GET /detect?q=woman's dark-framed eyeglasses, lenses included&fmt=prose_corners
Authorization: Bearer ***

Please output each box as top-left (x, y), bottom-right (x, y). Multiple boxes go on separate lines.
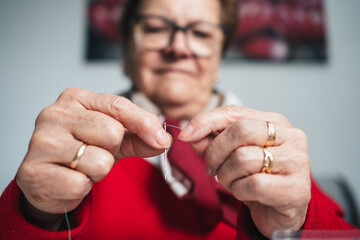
top-left (132, 15), bottom-right (225, 57)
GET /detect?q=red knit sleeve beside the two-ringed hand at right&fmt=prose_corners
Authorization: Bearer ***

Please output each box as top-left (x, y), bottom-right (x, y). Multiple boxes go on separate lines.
top-left (302, 180), bottom-right (355, 230)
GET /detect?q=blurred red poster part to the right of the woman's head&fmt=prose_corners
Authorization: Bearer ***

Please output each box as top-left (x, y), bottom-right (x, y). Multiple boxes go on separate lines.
top-left (229, 0), bottom-right (327, 62)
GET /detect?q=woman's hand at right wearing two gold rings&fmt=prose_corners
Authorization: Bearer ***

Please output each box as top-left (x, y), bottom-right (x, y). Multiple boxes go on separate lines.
top-left (179, 106), bottom-right (311, 237)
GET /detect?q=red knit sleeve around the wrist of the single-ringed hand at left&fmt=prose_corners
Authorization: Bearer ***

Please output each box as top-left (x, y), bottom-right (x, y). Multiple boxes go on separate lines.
top-left (0, 180), bottom-right (91, 240)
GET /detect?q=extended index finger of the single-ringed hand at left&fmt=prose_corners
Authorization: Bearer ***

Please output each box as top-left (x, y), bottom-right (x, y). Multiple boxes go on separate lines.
top-left (62, 88), bottom-right (170, 149)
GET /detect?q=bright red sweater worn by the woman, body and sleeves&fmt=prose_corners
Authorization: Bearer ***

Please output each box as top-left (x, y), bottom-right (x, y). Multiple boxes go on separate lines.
top-left (0, 157), bottom-right (353, 240)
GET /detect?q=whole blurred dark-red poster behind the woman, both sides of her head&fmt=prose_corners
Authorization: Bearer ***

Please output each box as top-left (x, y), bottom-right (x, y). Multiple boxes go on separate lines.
top-left (86, 0), bottom-right (327, 62)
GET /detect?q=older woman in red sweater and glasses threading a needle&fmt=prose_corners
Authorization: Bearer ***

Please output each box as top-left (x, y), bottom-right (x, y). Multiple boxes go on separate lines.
top-left (0, 0), bottom-right (351, 239)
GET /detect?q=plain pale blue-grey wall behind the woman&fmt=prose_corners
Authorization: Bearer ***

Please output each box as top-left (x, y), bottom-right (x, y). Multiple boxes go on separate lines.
top-left (0, 0), bottom-right (360, 218)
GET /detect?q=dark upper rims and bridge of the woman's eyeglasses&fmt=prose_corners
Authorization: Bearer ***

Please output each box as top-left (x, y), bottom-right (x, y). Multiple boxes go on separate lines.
top-left (130, 14), bottom-right (227, 56)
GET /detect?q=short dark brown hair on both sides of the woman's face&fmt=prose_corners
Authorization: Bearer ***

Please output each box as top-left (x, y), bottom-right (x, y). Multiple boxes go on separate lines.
top-left (118, 0), bottom-right (239, 57)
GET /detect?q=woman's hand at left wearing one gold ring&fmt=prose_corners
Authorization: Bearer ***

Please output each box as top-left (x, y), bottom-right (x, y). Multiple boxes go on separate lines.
top-left (16, 88), bottom-right (170, 216)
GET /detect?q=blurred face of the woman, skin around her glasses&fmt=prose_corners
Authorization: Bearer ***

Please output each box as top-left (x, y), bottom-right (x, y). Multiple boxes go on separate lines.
top-left (128, 0), bottom-right (222, 119)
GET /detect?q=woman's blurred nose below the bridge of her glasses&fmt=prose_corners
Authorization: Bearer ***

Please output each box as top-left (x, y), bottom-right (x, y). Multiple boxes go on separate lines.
top-left (166, 31), bottom-right (192, 57)
